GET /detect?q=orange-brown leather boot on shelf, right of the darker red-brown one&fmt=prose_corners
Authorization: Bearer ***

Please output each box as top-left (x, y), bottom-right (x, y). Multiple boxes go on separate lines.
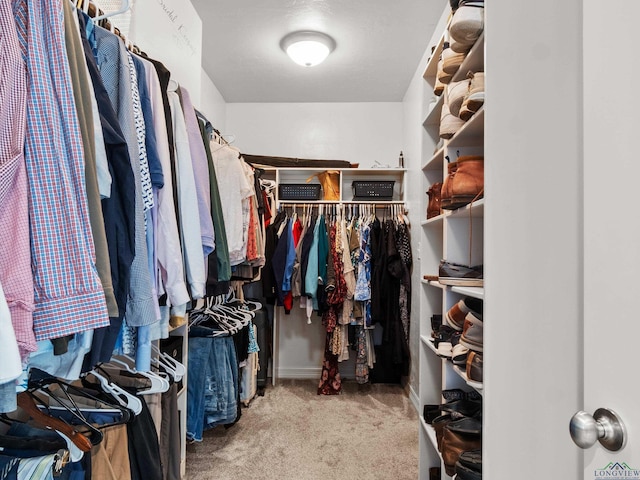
top-left (442, 155), bottom-right (484, 210)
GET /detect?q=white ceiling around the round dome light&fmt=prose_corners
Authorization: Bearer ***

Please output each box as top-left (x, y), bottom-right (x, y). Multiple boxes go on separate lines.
top-left (192, 0), bottom-right (443, 102)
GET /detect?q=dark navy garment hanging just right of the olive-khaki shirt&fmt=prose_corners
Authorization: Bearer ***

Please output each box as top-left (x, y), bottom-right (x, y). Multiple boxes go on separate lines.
top-left (78, 10), bottom-right (135, 371)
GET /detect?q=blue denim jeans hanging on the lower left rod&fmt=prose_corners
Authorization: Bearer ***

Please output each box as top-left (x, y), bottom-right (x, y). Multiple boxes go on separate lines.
top-left (187, 334), bottom-right (238, 442)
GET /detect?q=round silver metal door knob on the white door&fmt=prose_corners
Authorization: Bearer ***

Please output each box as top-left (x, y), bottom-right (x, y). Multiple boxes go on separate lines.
top-left (569, 408), bottom-right (627, 452)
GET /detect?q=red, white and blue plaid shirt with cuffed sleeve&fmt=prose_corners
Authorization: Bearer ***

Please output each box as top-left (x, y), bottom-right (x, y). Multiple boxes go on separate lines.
top-left (13, 0), bottom-right (109, 340)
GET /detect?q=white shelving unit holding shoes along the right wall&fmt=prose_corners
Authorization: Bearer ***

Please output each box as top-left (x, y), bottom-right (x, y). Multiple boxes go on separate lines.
top-left (418, 2), bottom-right (486, 480)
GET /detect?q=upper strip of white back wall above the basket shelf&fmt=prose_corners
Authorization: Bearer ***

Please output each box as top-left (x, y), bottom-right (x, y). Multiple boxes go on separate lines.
top-left (226, 102), bottom-right (402, 167)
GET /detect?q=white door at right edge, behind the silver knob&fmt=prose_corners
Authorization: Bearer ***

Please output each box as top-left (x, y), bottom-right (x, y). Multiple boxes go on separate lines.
top-left (582, 0), bottom-right (640, 480)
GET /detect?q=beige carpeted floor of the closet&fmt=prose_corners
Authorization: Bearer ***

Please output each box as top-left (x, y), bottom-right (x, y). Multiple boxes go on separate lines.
top-left (187, 380), bottom-right (418, 480)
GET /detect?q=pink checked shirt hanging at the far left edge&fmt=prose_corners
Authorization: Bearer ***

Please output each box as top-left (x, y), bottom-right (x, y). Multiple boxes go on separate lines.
top-left (0, 2), bottom-right (36, 356)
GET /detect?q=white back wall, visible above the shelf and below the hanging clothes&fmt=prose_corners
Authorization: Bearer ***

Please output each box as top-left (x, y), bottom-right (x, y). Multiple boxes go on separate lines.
top-left (224, 102), bottom-right (403, 379)
